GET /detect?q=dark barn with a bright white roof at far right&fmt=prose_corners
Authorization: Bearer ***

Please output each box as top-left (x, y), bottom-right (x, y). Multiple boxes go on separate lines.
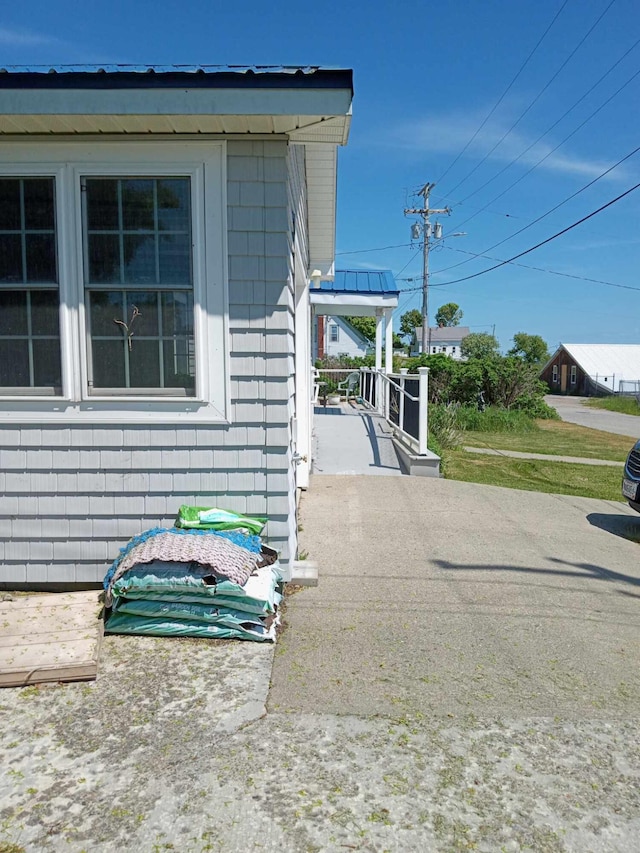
top-left (540, 344), bottom-right (640, 397)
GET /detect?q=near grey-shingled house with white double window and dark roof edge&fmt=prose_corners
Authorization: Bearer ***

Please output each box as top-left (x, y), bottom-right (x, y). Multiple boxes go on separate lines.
top-left (0, 66), bottom-right (353, 587)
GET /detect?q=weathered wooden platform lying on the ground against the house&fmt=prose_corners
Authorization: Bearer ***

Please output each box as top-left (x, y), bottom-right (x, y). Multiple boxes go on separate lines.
top-left (0, 590), bottom-right (102, 687)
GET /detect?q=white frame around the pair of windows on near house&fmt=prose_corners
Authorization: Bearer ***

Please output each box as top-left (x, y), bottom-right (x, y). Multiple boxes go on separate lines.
top-left (0, 139), bottom-right (230, 423)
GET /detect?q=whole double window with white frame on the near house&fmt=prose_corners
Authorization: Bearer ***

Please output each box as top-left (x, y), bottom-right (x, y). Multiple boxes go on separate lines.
top-left (0, 144), bottom-right (229, 423)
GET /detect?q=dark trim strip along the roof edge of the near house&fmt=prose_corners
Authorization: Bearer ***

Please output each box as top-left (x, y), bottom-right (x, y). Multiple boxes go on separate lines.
top-left (0, 65), bottom-right (353, 94)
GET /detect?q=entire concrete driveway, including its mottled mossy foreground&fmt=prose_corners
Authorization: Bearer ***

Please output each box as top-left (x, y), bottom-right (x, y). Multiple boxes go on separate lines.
top-left (0, 476), bottom-right (640, 853)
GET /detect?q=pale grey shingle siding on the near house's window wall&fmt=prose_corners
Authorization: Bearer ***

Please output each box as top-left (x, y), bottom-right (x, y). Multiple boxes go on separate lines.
top-left (0, 136), bottom-right (295, 586)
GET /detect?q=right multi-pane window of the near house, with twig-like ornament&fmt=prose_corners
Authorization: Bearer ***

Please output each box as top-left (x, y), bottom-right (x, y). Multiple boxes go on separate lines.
top-left (82, 177), bottom-right (195, 395)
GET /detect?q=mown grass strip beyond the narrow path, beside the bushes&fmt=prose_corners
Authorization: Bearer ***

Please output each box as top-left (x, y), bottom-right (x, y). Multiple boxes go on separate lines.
top-left (462, 421), bottom-right (632, 464)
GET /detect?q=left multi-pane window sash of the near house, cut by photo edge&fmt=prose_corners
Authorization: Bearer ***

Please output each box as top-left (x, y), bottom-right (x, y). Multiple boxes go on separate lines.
top-left (0, 177), bottom-right (62, 394)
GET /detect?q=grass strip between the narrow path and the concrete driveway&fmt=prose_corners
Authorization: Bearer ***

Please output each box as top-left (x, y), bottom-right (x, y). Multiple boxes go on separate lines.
top-left (447, 448), bottom-right (624, 503)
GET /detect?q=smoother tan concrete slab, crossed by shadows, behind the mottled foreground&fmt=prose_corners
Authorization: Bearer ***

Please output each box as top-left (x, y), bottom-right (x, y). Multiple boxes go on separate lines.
top-left (269, 477), bottom-right (640, 719)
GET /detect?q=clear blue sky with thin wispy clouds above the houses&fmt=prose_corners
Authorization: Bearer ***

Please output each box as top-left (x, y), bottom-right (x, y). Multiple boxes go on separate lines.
top-left (0, 0), bottom-right (640, 349)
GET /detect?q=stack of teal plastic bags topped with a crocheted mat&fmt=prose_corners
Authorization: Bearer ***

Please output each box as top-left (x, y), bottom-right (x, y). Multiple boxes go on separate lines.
top-left (104, 507), bottom-right (282, 641)
